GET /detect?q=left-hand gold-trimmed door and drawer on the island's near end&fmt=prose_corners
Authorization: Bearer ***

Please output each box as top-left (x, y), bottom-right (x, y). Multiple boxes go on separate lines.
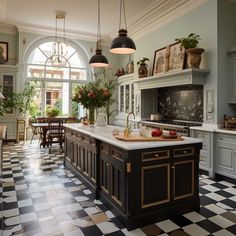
top-left (134, 149), bottom-right (170, 211)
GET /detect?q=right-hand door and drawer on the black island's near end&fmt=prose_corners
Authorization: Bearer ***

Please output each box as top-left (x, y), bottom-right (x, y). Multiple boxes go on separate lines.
top-left (171, 146), bottom-right (198, 200)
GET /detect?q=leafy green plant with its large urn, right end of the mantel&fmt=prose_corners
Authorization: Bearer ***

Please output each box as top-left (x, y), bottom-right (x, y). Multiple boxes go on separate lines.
top-left (175, 33), bottom-right (205, 68)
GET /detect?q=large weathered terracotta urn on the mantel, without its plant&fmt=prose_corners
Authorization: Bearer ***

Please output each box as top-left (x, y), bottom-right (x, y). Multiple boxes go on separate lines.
top-left (186, 48), bottom-right (205, 68)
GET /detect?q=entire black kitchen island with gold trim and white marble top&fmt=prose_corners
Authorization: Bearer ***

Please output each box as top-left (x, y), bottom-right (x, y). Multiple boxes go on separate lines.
top-left (64, 124), bottom-right (202, 230)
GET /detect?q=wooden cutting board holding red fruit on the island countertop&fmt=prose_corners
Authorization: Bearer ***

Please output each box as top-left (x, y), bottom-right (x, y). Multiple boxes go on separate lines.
top-left (114, 134), bottom-right (184, 142)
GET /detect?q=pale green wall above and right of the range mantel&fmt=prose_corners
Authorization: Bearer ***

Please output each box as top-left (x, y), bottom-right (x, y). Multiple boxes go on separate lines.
top-left (122, 0), bottom-right (217, 123)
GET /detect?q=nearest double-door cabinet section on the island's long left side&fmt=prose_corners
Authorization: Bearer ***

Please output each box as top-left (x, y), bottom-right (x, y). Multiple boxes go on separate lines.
top-left (100, 143), bottom-right (125, 211)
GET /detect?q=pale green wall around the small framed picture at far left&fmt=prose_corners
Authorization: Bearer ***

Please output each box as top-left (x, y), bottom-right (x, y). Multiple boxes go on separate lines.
top-left (0, 32), bottom-right (17, 65)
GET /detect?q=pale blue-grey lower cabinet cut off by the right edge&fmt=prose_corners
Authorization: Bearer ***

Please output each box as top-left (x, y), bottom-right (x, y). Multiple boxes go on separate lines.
top-left (215, 133), bottom-right (236, 179)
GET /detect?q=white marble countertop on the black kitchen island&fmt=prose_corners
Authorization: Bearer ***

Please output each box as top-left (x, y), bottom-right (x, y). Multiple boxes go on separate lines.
top-left (64, 123), bottom-right (202, 150)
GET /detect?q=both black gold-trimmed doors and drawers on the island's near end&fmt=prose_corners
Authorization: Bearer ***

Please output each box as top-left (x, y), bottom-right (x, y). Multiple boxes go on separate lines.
top-left (139, 146), bottom-right (198, 209)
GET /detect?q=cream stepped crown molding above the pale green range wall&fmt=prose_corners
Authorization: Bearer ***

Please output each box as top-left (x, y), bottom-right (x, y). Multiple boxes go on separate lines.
top-left (128, 0), bottom-right (209, 40)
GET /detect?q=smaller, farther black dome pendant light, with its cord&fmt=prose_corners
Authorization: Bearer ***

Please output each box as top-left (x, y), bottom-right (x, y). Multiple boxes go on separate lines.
top-left (89, 0), bottom-right (108, 67)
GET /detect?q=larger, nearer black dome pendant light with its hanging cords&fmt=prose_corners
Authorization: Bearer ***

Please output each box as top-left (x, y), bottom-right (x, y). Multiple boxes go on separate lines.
top-left (110, 0), bottom-right (136, 54)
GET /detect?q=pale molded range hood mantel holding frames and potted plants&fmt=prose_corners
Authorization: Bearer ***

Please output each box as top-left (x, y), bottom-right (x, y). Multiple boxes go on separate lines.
top-left (134, 68), bottom-right (210, 90)
